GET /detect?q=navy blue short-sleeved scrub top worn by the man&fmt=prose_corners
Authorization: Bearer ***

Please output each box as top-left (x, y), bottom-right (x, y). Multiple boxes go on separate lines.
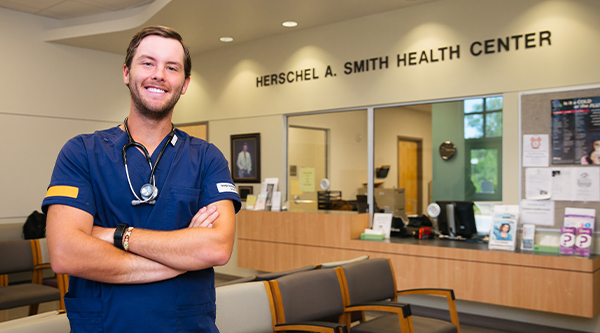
top-left (42, 127), bottom-right (241, 332)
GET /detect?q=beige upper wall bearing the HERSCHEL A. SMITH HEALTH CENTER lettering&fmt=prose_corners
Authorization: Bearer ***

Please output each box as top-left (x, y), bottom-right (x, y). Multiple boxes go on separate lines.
top-left (177, 0), bottom-right (600, 121)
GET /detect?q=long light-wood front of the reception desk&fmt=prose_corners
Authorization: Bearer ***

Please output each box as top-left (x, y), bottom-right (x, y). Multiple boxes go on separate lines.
top-left (237, 210), bottom-right (600, 318)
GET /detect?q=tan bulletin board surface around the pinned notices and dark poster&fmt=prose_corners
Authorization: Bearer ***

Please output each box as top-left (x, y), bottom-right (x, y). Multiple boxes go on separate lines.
top-left (520, 88), bottom-right (600, 232)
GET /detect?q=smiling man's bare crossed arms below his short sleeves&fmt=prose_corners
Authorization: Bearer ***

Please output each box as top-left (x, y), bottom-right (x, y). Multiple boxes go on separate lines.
top-left (46, 200), bottom-right (235, 284)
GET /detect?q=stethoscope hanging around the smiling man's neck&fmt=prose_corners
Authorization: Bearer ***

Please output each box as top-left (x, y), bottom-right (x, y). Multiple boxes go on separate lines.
top-left (121, 118), bottom-right (175, 206)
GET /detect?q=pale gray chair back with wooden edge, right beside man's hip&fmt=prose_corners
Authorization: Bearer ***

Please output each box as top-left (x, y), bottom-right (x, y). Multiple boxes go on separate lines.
top-left (216, 281), bottom-right (275, 333)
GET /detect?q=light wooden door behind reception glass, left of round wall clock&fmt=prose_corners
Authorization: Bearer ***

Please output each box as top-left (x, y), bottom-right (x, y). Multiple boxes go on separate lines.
top-left (398, 137), bottom-right (422, 215)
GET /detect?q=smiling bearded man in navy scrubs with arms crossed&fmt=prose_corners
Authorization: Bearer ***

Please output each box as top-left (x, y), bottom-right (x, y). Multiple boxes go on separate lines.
top-left (42, 26), bottom-right (241, 333)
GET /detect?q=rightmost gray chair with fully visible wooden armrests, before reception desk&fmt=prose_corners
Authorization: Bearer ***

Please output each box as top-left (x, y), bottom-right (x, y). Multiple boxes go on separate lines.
top-left (337, 258), bottom-right (460, 333)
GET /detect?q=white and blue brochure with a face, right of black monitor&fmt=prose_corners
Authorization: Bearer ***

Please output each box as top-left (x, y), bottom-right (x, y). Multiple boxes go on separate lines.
top-left (488, 205), bottom-right (519, 251)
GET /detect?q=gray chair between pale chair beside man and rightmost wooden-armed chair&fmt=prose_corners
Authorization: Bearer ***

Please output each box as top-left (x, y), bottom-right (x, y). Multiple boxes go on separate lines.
top-left (269, 268), bottom-right (348, 333)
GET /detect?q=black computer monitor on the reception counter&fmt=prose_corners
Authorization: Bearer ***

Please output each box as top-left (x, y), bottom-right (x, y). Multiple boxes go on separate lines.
top-left (437, 200), bottom-right (477, 238)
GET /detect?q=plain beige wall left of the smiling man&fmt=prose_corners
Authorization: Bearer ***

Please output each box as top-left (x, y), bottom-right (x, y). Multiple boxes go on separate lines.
top-left (0, 9), bottom-right (129, 223)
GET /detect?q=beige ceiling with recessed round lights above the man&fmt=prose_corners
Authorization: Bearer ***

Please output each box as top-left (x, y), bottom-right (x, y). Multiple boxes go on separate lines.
top-left (0, 0), bottom-right (439, 54)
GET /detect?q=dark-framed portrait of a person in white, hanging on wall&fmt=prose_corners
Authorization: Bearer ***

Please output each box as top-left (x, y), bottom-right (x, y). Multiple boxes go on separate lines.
top-left (231, 133), bottom-right (260, 183)
